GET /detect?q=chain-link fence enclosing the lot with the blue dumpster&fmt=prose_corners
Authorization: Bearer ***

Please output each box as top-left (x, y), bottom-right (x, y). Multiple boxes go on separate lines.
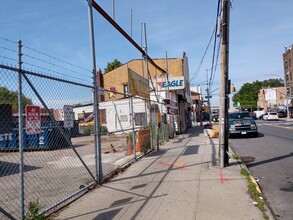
top-left (0, 40), bottom-right (172, 219)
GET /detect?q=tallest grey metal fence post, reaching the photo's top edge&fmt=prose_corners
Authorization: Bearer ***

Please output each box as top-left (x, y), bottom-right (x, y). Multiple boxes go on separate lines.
top-left (88, 0), bottom-right (103, 184)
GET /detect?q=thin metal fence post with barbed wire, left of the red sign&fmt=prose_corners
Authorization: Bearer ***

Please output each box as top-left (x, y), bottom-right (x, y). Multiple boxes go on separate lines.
top-left (17, 40), bottom-right (25, 219)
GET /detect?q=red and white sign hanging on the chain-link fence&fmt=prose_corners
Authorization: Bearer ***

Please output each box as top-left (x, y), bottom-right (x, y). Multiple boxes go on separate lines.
top-left (25, 105), bottom-right (41, 134)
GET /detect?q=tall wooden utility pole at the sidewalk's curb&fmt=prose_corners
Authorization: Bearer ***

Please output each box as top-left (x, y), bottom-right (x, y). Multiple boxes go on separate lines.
top-left (219, 0), bottom-right (230, 168)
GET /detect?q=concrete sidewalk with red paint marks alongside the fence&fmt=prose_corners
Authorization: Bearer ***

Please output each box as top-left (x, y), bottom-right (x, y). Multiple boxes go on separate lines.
top-left (54, 127), bottom-right (270, 220)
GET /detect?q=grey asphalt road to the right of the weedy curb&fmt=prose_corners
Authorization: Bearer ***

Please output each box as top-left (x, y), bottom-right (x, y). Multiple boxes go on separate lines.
top-left (229, 121), bottom-right (293, 220)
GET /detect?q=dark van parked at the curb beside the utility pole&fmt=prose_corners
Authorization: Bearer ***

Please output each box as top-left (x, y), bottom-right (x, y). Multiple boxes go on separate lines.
top-left (229, 112), bottom-right (258, 137)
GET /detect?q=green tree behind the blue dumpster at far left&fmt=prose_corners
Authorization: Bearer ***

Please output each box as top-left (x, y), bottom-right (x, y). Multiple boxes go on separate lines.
top-left (0, 87), bottom-right (33, 109)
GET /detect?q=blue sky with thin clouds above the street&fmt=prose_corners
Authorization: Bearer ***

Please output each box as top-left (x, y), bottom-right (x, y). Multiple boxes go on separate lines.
top-left (0, 0), bottom-right (293, 105)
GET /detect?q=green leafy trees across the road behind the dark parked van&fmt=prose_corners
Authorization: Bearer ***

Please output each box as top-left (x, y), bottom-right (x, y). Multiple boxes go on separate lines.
top-left (233, 79), bottom-right (284, 110)
